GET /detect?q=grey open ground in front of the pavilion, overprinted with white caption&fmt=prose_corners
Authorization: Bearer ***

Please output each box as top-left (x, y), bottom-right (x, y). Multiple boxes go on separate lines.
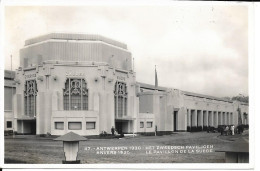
top-left (5, 132), bottom-right (248, 164)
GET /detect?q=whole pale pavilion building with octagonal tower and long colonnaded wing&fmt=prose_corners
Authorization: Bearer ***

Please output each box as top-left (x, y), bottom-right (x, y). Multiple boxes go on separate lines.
top-left (4, 33), bottom-right (249, 135)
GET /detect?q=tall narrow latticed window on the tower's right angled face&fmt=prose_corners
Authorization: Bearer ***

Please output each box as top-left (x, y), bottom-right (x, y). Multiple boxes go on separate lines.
top-left (114, 81), bottom-right (127, 118)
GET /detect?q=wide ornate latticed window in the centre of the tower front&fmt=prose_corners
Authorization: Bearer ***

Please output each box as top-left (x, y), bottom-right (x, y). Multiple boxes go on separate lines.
top-left (63, 78), bottom-right (88, 110)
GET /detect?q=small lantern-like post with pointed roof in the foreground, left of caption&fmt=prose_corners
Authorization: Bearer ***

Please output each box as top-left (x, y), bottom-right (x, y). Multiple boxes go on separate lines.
top-left (54, 132), bottom-right (87, 164)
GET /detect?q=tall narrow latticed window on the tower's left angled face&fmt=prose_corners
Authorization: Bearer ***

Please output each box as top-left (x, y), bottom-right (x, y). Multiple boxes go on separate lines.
top-left (24, 80), bottom-right (37, 117)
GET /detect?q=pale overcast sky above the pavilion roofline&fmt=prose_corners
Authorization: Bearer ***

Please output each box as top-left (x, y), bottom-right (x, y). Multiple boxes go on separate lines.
top-left (4, 5), bottom-right (248, 97)
